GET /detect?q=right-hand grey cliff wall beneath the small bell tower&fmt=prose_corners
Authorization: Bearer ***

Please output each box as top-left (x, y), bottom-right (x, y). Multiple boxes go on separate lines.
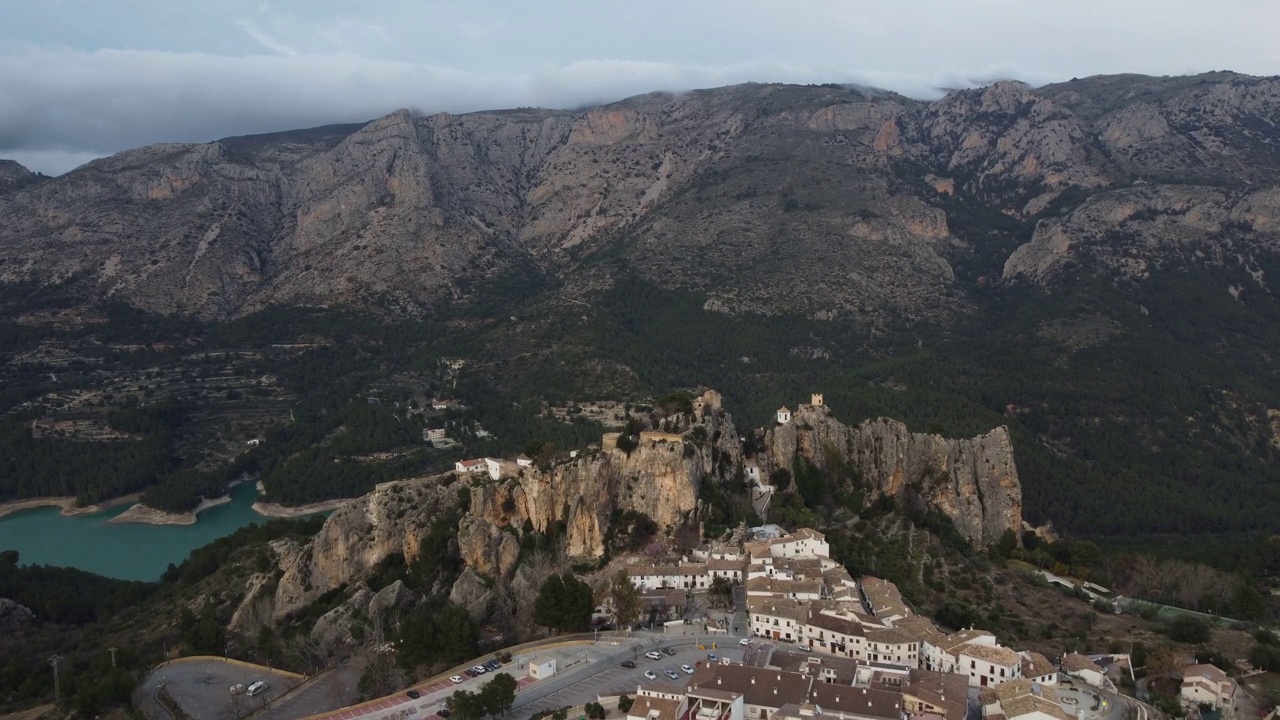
top-left (758, 405), bottom-right (1023, 547)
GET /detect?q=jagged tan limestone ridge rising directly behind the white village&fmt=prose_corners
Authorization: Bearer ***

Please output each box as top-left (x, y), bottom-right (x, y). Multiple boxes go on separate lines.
top-left (264, 392), bottom-right (1021, 634)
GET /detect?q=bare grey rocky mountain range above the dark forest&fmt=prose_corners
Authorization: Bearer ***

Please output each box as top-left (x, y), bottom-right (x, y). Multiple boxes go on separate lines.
top-left (0, 73), bottom-right (1280, 325)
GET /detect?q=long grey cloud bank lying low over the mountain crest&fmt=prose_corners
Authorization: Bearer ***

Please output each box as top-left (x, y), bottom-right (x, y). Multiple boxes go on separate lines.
top-left (0, 45), bottom-right (1059, 173)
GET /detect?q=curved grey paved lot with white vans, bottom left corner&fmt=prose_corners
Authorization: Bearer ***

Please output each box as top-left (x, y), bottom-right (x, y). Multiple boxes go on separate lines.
top-left (138, 660), bottom-right (298, 720)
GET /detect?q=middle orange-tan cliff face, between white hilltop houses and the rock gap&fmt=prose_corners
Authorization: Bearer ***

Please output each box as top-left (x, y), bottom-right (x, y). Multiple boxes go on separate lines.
top-left (458, 411), bottom-right (741, 578)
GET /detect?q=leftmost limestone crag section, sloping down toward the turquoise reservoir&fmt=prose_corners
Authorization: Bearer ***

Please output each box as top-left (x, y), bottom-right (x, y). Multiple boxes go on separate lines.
top-left (273, 477), bottom-right (457, 619)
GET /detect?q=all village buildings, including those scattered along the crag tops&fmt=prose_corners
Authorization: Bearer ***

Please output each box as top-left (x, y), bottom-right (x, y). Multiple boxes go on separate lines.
top-left (442, 391), bottom-right (1245, 720)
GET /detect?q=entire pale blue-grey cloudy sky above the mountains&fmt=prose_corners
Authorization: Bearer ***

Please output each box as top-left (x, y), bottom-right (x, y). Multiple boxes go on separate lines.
top-left (0, 0), bottom-right (1280, 174)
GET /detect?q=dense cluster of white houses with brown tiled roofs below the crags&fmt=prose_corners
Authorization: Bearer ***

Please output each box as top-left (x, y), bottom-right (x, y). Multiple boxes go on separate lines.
top-left (604, 525), bottom-right (1128, 720)
